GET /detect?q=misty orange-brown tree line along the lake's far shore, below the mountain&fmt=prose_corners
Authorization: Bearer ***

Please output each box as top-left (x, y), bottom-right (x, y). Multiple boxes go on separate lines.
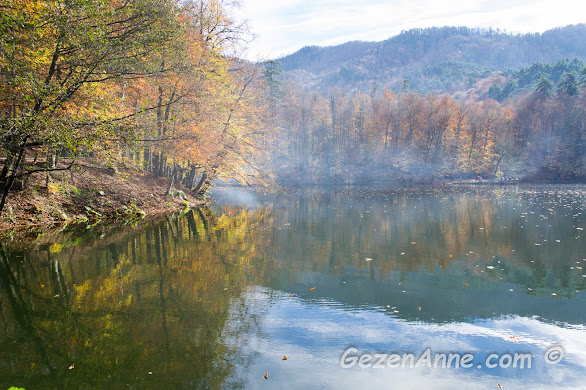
top-left (274, 64), bottom-right (586, 183)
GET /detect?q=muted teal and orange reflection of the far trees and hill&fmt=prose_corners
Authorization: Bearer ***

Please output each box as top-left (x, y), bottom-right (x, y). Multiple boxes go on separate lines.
top-left (238, 188), bottom-right (586, 324)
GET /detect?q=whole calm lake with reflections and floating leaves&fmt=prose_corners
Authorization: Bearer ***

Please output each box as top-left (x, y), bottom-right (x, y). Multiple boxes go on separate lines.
top-left (0, 185), bottom-right (586, 389)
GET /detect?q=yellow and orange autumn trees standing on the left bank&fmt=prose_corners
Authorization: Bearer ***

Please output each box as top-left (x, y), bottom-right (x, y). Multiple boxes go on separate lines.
top-left (0, 0), bottom-right (265, 212)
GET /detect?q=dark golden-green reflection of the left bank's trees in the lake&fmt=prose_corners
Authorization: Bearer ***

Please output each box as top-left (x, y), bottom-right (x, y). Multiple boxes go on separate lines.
top-left (0, 209), bottom-right (271, 388)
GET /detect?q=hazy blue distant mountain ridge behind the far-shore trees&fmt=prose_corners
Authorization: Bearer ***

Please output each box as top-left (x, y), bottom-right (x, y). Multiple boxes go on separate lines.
top-left (278, 24), bottom-right (586, 93)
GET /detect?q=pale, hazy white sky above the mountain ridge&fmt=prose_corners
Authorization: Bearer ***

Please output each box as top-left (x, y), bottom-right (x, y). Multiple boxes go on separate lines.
top-left (237, 0), bottom-right (586, 60)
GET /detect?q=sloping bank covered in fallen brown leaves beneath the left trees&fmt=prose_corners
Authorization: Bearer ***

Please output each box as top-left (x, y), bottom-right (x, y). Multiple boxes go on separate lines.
top-left (0, 162), bottom-right (205, 230)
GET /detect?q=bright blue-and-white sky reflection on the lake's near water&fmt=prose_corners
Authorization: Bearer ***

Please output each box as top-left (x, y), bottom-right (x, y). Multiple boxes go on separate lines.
top-left (228, 287), bottom-right (586, 389)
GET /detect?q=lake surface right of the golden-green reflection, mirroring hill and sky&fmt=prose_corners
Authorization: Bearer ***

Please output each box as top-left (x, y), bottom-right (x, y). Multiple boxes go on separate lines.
top-left (215, 186), bottom-right (586, 389)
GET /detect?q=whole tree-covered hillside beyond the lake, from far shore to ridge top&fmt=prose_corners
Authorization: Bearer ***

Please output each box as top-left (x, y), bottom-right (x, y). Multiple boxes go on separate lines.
top-left (266, 24), bottom-right (586, 183)
